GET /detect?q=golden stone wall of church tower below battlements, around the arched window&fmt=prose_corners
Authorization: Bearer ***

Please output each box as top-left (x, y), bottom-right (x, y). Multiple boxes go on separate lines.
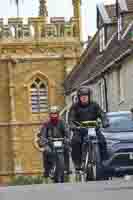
top-left (0, 18), bottom-right (81, 182)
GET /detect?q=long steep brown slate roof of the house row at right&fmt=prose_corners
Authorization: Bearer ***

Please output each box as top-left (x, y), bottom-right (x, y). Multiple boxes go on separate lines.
top-left (64, 0), bottom-right (133, 93)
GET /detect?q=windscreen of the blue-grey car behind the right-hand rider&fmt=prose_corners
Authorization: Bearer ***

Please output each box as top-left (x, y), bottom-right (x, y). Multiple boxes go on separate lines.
top-left (104, 115), bottom-right (133, 132)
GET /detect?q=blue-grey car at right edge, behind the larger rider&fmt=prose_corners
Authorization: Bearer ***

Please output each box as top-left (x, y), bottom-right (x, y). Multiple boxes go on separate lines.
top-left (97, 111), bottom-right (133, 177)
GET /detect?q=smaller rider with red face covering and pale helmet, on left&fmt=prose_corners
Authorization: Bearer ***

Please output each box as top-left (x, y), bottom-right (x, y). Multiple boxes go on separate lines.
top-left (38, 106), bottom-right (70, 181)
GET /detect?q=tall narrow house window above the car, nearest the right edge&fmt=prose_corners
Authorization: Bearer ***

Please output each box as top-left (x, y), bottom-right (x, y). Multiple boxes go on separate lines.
top-left (117, 68), bottom-right (124, 103)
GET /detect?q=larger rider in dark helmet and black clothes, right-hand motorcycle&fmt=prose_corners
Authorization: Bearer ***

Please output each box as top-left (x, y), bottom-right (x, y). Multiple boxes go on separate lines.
top-left (69, 86), bottom-right (108, 169)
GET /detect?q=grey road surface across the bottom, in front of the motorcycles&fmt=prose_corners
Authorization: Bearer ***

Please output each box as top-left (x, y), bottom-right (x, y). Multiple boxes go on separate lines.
top-left (0, 180), bottom-right (133, 200)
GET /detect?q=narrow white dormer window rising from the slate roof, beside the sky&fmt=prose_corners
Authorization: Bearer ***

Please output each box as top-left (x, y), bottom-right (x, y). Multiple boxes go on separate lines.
top-left (99, 27), bottom-right (106, 52)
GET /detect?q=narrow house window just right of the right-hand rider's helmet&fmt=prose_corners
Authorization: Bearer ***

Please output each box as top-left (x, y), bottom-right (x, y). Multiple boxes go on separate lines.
top-left (98, 81), bottom-right (106, 111)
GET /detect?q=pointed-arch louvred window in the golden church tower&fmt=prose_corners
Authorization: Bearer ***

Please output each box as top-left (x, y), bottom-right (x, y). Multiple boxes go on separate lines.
top-left (30, 78), bottom-right (48, 113)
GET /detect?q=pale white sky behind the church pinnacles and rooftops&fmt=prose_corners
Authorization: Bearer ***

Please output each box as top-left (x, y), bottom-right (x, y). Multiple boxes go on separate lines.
top-left (0, 0), bottom-right (115, 41)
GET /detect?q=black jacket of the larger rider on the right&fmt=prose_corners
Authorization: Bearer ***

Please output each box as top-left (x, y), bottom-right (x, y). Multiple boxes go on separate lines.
top-left (69, 102), bottom-right (108, 127)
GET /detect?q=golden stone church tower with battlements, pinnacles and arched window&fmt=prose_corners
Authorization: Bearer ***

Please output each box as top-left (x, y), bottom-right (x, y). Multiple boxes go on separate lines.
top-left (0, 0), bottom-right (81, 183)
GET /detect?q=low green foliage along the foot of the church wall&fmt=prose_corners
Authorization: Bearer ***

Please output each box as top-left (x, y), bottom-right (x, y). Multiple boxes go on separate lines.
top-left (9, 176), bottom-right (44, 185)
